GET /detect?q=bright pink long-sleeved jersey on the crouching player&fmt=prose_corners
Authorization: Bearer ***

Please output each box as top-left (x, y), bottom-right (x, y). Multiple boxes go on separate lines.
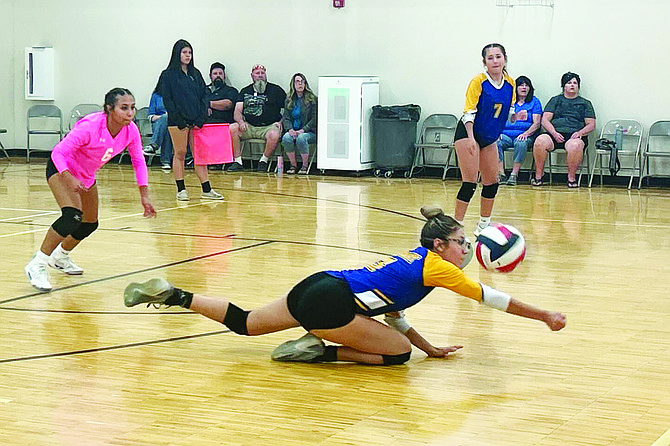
top-left (51, 112), bottom-right (148, 188)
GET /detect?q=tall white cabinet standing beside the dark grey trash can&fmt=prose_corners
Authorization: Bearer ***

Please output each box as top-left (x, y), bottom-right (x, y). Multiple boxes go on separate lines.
top-left (316, 76), bottom-right (379, 171)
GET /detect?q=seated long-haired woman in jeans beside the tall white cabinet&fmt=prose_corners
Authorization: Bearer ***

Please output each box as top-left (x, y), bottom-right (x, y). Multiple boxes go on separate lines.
top-left (281, 73), bottom-right (317, 175)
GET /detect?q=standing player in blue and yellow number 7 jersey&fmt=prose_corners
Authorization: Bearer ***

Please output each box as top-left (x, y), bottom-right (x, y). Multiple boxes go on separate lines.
top-left (454, 43), bottom-right (528, 236)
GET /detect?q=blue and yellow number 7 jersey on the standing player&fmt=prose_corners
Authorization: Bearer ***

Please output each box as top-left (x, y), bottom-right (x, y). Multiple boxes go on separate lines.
top-left (463, 73), bottom-right (516, 142)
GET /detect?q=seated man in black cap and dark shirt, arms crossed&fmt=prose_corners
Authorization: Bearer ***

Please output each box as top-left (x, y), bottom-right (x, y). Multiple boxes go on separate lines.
top-left (205, 62), bottom-right (242, 170)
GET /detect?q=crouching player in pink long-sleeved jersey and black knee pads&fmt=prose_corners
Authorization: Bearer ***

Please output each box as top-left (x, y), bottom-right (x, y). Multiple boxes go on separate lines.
top-left (25, 88), bottom-right (156, 291)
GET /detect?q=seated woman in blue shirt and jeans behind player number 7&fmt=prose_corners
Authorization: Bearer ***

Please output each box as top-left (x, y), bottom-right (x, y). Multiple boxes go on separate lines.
top-left (497, 76), bottom-right (542, 186)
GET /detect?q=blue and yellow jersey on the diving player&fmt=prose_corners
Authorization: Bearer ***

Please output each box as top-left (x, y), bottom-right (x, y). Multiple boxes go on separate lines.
top-left (326, 247), bottom-right (482, 316)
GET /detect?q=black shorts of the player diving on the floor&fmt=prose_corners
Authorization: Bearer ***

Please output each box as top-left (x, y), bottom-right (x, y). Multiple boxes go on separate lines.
top-left (287, 272), bottom-right (356, 330)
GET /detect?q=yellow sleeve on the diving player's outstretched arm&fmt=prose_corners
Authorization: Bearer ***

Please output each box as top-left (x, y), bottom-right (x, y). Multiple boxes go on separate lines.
top-left (423, 251), bottom-right (482, 302)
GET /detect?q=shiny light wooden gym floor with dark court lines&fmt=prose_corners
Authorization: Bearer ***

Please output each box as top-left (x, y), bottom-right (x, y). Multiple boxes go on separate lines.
top-left (0, 158), bottom-right (670, 446)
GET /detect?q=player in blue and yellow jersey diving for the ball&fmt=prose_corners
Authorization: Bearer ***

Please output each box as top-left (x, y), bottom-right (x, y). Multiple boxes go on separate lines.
top-left (124, 207), bottom-right (566, 365)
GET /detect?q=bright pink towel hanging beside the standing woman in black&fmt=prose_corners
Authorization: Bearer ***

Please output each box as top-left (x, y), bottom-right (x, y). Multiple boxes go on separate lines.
top-left (193, 124), bottom-right (233, 166)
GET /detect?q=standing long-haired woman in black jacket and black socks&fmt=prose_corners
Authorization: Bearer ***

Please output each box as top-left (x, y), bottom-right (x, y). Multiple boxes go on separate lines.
top-left (159, 39), bottom-right (223, 201)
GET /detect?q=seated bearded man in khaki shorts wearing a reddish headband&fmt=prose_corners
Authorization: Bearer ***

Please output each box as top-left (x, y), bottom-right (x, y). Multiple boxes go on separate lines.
top-left (235, 65), bottom-right (286, 172)
